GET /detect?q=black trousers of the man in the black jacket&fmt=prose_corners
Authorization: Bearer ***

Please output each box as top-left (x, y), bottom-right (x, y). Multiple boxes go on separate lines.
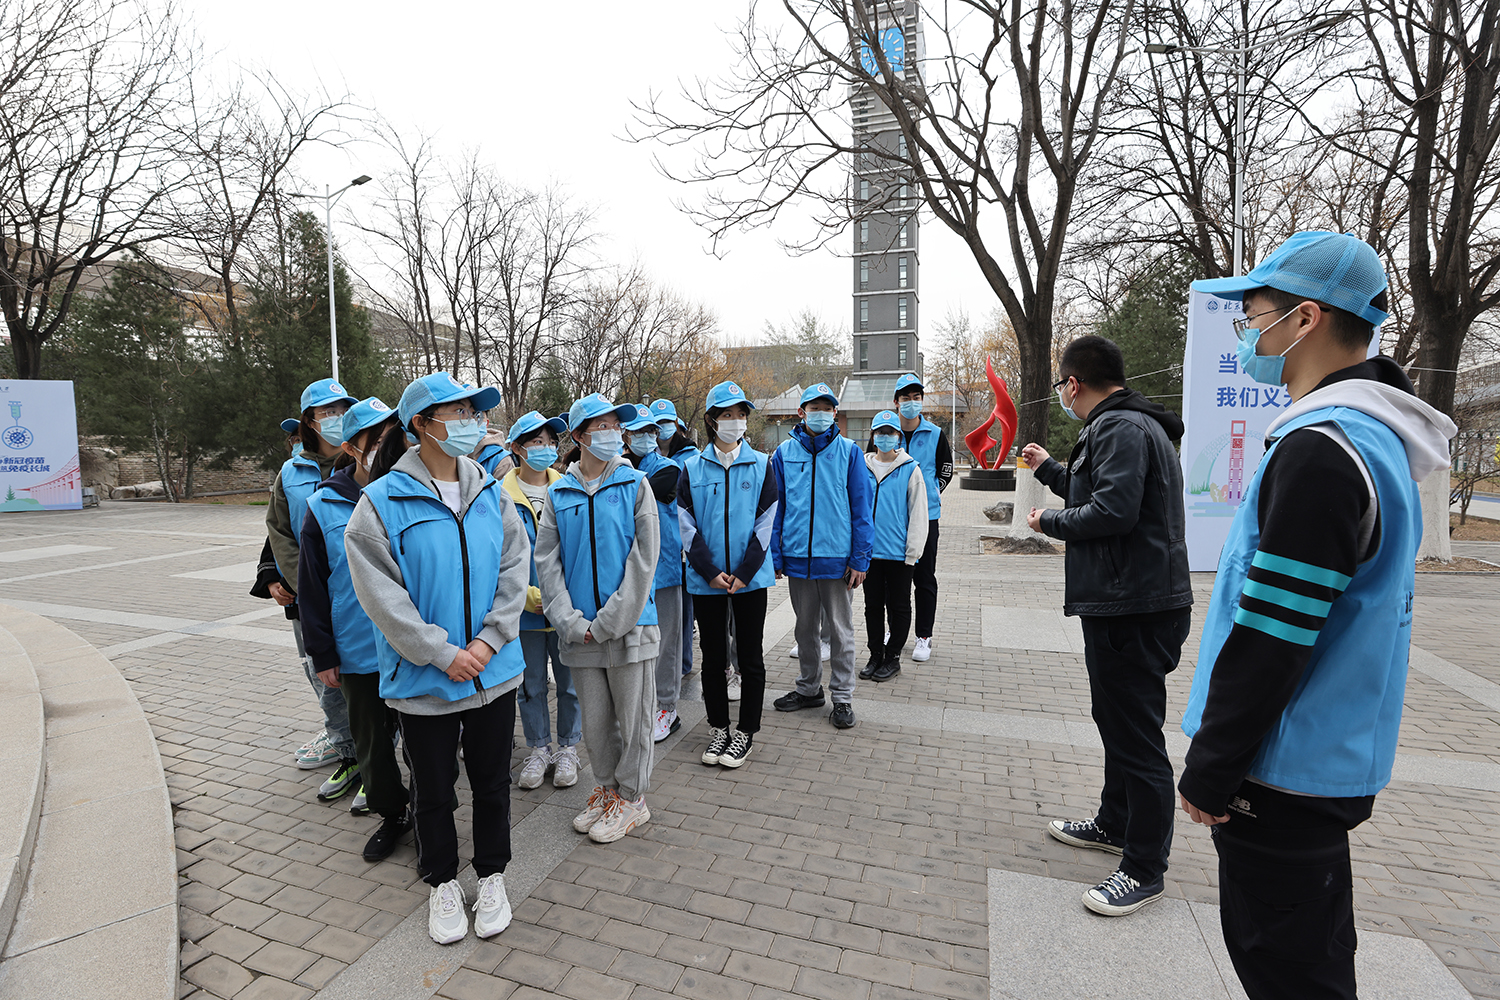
top-left (1082, 607), bottom-right (1191, 885)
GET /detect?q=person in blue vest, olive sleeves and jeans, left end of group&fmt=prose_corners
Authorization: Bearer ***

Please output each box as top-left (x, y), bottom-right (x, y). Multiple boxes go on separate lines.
top-left (266, 378), bottom-right (359, 799)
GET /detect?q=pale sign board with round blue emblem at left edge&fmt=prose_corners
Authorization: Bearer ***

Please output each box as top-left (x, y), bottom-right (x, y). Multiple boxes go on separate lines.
top-left (0, 379), bottom-right (84, 511)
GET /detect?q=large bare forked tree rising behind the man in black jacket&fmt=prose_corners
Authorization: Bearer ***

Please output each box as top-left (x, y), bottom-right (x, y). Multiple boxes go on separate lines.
top-left (635, 0), bottom-right (1137, 441)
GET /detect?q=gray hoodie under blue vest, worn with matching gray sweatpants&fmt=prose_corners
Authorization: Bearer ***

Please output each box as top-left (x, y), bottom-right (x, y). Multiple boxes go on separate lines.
top-left (536, 457), bottom-right (662, 667)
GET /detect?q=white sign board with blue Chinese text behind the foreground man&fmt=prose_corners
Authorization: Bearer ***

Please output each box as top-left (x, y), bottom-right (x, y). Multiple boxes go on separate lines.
top-left (1182, 291), bottom-right (1292, 571)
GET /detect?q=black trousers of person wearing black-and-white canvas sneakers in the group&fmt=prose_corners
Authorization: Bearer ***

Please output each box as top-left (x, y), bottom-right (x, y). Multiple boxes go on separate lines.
top-left (693, 588), bottom-right (767, 733)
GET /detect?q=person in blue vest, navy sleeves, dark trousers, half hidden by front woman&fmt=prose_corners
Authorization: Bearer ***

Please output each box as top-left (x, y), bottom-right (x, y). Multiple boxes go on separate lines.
top-left (297, 396), bottom-right (411, 862)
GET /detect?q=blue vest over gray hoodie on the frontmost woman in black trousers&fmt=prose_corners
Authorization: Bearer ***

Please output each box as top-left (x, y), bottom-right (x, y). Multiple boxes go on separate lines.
top-left (365, 459), bottom-right (525, 702)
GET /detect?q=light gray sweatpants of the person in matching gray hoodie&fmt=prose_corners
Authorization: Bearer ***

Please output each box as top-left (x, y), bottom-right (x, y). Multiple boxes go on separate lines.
top-left (573, 660), bottom-right (656, 802)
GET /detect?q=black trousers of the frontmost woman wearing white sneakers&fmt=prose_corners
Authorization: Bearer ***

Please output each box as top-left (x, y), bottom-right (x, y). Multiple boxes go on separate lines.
top-left (396, 691), bottom-right (516, 886)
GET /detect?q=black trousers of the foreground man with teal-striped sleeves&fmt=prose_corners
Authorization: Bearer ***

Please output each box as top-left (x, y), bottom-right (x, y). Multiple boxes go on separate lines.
top-left (1214, 781), bottom-right (1376, 1000)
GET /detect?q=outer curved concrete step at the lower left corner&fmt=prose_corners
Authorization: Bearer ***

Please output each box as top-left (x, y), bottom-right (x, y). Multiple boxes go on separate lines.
top-left (0, 604), bottom-right (177, 1000)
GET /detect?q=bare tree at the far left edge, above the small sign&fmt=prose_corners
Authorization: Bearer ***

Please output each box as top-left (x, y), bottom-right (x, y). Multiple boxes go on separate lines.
top-left (0, 0), bottom-right (195, 378)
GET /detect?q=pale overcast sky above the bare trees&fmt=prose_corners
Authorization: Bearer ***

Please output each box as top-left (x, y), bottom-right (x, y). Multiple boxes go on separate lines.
top-left (188, 0), bottom-right (995, 357)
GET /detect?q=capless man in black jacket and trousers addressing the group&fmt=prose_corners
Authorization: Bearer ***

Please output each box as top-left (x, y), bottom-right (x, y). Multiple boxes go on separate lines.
top-left (1022, 336), bottom-right (1193, 916)
